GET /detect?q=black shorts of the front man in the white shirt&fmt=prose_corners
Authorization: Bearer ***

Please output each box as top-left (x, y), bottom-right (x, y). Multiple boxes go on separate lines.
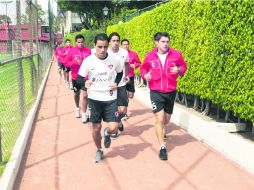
top-left (88, 98), bottom-right (119, 123)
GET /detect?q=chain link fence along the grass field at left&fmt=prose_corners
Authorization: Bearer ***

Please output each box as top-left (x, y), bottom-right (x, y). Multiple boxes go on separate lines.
top-left (0, 0), bottom-right (52, 174)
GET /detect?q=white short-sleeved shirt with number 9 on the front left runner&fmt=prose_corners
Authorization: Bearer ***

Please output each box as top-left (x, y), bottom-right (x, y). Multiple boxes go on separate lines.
top-left (78, 54), bottom-right (122, 101)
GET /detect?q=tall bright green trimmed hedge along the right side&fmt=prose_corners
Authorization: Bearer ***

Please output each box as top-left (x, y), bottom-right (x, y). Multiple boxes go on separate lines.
top-left (107, 0), bottom-right (254, 122)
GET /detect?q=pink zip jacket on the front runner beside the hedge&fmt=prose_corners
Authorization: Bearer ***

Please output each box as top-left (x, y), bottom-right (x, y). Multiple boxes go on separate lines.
top-left (140, 48), bottom-right (187, 93)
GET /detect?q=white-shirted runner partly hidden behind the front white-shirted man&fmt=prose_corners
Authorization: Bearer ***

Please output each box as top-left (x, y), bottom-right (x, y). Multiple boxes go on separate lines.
top-left (108, 32), bottom-right (129, 135)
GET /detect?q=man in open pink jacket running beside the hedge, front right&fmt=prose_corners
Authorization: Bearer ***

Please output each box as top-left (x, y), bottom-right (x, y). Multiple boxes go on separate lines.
top-left (140, 32), bottom-right (186, 160)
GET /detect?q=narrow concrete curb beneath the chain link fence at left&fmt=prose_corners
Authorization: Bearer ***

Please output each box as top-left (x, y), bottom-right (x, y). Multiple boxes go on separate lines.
top-left (0, 63), bottom-right (52, 190)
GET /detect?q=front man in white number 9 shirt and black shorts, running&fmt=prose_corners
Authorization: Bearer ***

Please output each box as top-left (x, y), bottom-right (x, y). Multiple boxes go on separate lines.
top-left (78, 33), bottom-right (123, 162)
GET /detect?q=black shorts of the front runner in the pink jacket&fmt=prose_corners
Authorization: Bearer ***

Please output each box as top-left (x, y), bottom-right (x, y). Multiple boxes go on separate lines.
top-left (150, 90), bottom-right (176, 114)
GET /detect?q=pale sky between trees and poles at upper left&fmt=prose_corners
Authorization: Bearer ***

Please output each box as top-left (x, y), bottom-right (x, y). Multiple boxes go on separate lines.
top-left (0, 0), bottom-right (57, 24)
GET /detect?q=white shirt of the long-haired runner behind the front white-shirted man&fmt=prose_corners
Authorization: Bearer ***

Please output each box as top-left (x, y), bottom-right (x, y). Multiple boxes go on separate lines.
top-left (108, 47), bottom-right (129, 86)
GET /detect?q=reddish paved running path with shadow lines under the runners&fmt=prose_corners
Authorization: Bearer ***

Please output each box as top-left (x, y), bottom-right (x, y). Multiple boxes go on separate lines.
top-left (14, 65), bottom-right (254, 190)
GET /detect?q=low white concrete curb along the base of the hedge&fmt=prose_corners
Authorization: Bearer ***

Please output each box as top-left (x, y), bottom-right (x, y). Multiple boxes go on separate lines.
top-left (135, 88), bottom-right (254, 174)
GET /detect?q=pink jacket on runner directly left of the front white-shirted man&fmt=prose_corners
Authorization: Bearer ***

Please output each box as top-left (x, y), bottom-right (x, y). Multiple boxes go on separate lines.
top-left (64, 46), bottom-right (91, 80)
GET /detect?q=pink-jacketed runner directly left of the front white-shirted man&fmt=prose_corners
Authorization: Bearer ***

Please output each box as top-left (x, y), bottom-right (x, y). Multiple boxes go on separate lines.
top-left (65, 34), bottom-right (91, 123)
